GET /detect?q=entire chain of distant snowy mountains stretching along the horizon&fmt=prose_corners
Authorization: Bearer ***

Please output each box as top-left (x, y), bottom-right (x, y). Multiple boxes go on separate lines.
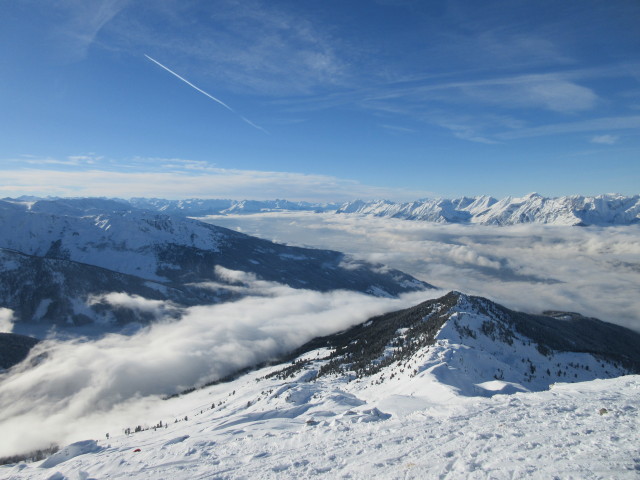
top-left (5, 193), bottom-right (640, 226)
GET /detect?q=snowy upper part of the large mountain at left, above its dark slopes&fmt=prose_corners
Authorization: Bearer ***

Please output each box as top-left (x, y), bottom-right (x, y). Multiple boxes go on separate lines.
top-left (0, 199), bottom-right (225, 280)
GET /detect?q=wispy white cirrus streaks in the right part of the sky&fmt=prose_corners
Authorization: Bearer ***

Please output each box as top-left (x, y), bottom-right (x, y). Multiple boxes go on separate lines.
top-left (318, 69), bottom-right (621, 144)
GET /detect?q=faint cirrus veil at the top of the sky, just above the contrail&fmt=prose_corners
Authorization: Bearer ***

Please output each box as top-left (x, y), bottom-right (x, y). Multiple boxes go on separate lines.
top-left (110, 0), bottom-right (349, 96)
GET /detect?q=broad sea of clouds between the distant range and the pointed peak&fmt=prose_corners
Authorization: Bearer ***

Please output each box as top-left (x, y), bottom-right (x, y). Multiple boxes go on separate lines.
top-left (200, 212), bottom-right (640, 330)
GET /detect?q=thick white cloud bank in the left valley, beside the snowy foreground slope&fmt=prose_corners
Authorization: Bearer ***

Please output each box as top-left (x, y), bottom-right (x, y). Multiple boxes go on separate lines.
top-left (0, 272), bottom-right (442, 456)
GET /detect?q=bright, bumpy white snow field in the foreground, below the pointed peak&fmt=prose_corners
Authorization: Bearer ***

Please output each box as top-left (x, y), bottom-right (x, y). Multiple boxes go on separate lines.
top-left (0, 370), bottom-right (640, 479)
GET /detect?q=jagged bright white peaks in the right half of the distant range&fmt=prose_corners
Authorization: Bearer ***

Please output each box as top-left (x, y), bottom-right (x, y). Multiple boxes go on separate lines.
top-left (337, 193), bottom-right (640, 226)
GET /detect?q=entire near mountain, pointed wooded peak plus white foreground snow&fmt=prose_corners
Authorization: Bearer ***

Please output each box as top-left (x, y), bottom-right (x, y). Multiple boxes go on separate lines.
top-left (0, 292), bottom-right (640, 479)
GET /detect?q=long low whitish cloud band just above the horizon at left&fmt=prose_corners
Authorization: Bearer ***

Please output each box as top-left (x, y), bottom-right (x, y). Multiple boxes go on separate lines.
top-left (0, 167), bottom-right (433, 202)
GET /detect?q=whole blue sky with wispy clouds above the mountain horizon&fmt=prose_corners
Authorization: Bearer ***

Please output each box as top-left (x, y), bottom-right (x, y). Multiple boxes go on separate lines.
top-left (0, 0), bottom-right (640, 200)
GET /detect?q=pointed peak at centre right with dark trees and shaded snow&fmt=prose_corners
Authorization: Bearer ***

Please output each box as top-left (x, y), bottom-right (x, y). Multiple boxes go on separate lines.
top-left (278, 292), bottom-right (640, 396)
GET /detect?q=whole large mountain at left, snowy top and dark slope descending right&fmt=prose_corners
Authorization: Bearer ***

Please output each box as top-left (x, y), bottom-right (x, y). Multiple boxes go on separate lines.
top-left (0, 199), bottom-right (428, 325)
